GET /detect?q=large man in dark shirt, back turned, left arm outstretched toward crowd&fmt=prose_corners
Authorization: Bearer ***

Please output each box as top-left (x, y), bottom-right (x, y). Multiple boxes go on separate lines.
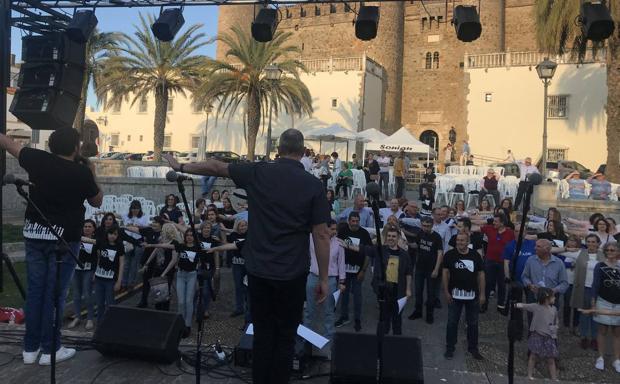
top-left (164, 129), bottom-right (330, 384)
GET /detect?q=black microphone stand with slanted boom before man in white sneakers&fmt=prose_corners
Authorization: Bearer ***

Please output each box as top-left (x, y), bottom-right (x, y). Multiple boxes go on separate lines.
top-left (15, 185), bottom-right (84, 384)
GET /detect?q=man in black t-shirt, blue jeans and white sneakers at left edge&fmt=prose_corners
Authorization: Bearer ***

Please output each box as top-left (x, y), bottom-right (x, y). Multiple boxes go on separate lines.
top-left (0, 128), bottom-right (103, 365)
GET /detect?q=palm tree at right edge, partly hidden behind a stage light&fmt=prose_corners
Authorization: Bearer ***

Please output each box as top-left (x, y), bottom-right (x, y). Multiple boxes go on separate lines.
top-left (534, 0), bottom-right (620, 182)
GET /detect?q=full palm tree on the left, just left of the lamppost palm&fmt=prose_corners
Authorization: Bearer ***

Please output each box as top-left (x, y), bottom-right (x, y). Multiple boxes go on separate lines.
top-left (96, 15), bottom-right (212, 161)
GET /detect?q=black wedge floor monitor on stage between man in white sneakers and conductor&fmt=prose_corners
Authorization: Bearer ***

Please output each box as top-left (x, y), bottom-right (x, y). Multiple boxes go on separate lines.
top-left (93, 305), bottom-right (185, 364)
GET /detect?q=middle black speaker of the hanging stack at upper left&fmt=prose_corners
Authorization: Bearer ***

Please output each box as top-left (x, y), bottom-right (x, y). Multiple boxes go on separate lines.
top-left (17, 63), bottom-right (85, 97)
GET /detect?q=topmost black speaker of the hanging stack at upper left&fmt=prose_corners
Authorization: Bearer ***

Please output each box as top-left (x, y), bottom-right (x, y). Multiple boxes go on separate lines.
top-left (22, 32), bottom-right (86, 67)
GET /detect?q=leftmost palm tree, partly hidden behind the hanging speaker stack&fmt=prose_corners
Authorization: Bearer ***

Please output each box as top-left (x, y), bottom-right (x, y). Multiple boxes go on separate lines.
top-left (73, 30), bottom-right (121, 133)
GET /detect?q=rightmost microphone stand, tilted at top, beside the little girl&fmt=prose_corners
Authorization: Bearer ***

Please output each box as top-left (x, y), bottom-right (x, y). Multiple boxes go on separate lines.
top-left (506, 181), bottom-right (534, 384)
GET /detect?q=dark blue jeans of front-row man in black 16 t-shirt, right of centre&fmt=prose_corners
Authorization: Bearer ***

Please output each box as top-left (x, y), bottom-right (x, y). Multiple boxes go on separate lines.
top-left (446, 297), bottom-right (480, 352)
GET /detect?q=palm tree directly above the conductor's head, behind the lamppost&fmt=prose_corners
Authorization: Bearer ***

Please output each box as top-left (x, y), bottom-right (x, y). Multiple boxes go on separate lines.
top-left (194, 26), bottom-right (312, 160)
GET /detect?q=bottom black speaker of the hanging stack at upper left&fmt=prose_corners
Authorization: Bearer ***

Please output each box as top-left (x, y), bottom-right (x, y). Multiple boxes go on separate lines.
top-left (9, 88), bottom-right (80, 130)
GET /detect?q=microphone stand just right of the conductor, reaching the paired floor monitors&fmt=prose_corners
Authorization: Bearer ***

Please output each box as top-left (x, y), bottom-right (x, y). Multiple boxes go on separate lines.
top-left (371, 190), bottom-right (389, 383)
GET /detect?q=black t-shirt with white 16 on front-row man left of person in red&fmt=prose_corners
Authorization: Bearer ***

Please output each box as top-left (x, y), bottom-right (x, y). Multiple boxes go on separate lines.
top-left (443, 249), bottom-right (483, 300)
